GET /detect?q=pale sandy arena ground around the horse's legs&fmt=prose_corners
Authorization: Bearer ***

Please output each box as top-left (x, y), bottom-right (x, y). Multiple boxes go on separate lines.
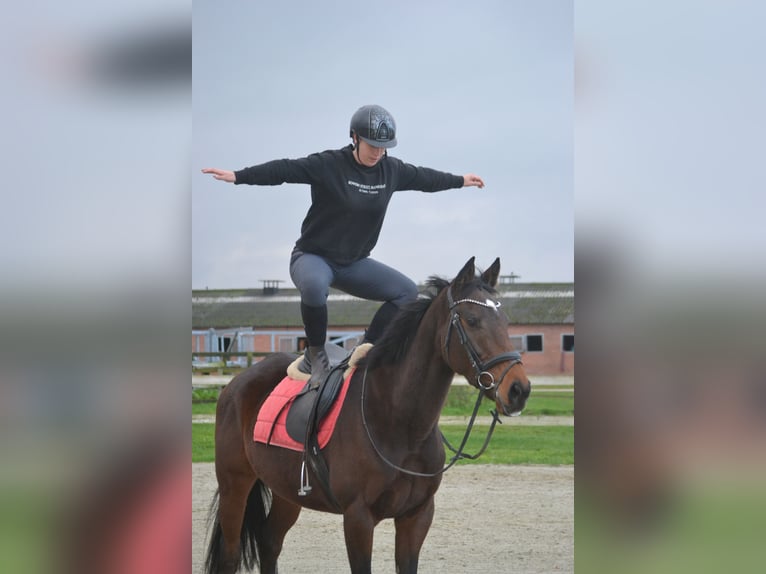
top-left (192, 463), bottom-right (574, 574)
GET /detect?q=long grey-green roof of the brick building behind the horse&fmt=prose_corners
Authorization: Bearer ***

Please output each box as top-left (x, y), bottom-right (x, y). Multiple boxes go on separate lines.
top-left (192, 283), bottom-right (574, 329)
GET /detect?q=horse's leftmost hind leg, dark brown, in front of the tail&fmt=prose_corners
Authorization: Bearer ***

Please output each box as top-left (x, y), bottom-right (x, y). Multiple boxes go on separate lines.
top-left (218, 474), bottom-right (255, 574)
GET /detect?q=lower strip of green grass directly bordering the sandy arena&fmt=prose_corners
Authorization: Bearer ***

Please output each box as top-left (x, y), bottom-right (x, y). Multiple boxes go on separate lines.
top-left (192, 423), bottom-right (574, 465)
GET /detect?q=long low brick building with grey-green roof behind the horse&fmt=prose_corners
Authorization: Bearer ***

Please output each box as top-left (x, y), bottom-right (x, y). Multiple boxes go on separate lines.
top-left (192, 283), bottom-right (574, 375)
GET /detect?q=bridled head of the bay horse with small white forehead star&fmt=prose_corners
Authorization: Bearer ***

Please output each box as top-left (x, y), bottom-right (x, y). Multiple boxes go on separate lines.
top-left (441, 257), bottom-right (531, 416)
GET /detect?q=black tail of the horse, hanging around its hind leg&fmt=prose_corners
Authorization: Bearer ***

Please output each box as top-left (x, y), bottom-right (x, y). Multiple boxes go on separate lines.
top-left (205, 480), bottom-right (271, 574)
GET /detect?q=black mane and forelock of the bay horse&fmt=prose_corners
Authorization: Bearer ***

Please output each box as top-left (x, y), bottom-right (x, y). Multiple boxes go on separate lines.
top-left (365, 276), bottom-right (495, 369)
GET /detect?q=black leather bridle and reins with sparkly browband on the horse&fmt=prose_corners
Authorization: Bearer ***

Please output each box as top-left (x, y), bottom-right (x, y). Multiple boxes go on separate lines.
top-left (361, 285), bottom-right (521, 478)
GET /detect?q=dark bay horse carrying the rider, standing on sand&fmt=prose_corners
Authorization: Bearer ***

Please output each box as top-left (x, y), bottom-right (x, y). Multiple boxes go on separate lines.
top-left (206, 258), bottom-right (530, 574)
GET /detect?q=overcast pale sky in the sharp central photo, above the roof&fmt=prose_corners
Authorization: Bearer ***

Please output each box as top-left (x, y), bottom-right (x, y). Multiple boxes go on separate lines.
top-left (191, 0), bottom-right (574, 289)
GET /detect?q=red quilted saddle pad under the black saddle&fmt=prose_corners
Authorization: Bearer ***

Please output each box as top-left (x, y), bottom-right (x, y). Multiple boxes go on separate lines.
top-left (253, 369), bottom-right (354, 451)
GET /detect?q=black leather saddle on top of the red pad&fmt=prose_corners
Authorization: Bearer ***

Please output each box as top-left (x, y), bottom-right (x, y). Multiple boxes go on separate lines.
top-left (285, 343), bottom-right (351, 445)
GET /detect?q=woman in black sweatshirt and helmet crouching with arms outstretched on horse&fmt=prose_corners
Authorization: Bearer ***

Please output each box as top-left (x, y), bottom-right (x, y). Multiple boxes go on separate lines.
top-left (202, 105), bottom-right (484, 390)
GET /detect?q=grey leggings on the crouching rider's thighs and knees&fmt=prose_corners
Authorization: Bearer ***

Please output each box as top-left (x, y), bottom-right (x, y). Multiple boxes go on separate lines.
top-left (290, 250), bottom-right (418, 307)
